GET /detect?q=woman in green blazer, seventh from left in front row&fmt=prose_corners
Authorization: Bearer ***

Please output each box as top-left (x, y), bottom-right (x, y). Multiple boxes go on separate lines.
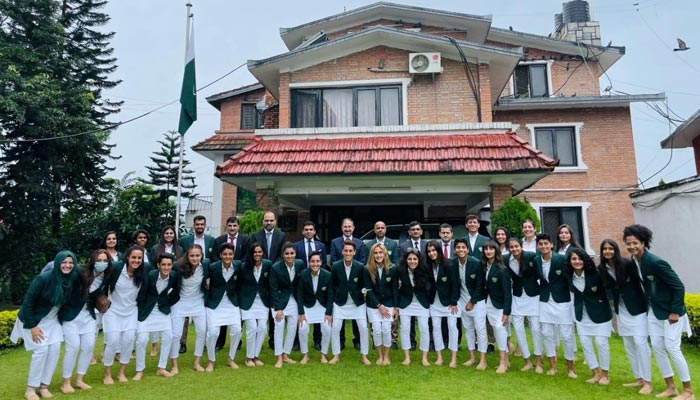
top-left (238, 243), bottom-right (272, 367)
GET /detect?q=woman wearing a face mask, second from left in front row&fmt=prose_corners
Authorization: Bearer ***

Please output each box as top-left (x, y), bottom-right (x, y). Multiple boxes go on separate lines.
top-left (60, 250), bottom-right (112, 393)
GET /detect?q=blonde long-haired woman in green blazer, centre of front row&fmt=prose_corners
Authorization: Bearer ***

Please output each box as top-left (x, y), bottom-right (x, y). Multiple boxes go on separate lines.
top-left (364, 244), bottom-right (399, 365)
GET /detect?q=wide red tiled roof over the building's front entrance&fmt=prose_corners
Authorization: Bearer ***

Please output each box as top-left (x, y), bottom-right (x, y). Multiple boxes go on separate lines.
top-left (216, 132), bottom-right (559, 176)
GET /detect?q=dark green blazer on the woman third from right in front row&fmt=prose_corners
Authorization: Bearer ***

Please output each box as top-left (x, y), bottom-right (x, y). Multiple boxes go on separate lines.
top-left (569, 269), bottom-right (612, 324)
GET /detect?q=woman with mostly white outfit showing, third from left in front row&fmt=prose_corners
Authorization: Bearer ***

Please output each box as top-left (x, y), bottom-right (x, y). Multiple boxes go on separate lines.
top-left (102, 246), bottom-right (146, 385)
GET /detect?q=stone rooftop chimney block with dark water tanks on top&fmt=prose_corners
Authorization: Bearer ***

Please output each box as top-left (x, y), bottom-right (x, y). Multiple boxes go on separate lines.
top-left (552, 0), bottom-right (600, 46)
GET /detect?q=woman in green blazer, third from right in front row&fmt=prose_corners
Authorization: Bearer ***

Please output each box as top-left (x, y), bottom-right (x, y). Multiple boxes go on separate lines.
top-left (566, 248), bottom-right (612, 386)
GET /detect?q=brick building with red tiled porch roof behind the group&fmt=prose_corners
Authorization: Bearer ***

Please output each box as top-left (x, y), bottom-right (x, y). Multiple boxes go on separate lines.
top-left (193, 2), bottom-right (664, 248)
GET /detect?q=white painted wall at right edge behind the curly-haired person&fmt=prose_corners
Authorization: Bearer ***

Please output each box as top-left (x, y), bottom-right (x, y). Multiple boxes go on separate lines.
top-left (632, 178), bottom-right (700, 293)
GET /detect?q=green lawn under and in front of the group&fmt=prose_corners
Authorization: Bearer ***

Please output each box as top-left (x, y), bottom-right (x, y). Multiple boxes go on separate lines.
top-left (0, 328), bottom-right (700, 400)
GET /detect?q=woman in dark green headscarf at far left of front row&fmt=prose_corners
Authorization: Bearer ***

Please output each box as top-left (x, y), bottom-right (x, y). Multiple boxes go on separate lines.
top-left (11, 250), bottom-right (78, 400)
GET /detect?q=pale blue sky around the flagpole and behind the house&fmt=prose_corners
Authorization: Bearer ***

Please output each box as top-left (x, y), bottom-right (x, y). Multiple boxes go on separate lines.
top-left (105, 0), bottom-right (700, 196)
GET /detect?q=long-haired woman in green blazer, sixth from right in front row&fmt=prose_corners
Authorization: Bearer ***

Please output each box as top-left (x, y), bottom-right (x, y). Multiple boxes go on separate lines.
top-left (481, 240), bottom-right (513, 374)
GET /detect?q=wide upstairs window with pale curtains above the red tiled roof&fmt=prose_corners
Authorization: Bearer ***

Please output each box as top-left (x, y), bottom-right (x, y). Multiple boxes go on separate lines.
top-left (292, 85), bottom-right (402, 128)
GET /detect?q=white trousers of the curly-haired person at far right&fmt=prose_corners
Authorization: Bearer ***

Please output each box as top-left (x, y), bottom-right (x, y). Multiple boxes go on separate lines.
top-left (649, 322), bottom-right (690, 382)
